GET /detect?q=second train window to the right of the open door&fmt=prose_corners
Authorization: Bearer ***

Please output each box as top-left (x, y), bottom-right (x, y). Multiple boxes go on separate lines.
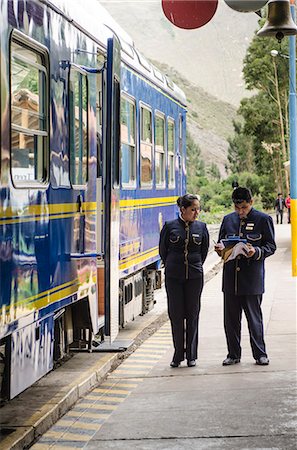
top-left (140, 106), bottom-right (153, 187)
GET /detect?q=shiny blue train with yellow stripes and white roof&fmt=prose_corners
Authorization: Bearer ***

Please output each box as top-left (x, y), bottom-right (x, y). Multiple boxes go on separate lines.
top-left (0, 0), bottom-right (186, 399)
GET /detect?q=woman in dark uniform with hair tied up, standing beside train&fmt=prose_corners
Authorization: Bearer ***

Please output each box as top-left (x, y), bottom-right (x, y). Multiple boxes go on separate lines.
top-left (159, 194), bottom-right (209, 367)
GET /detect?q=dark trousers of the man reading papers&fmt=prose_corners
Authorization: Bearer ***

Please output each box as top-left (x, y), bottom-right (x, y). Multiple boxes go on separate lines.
top-left (224, 293), bottom-right (267, 359)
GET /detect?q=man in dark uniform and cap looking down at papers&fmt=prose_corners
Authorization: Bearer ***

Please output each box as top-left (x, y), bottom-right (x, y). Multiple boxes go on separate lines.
top-left (215, 187), bottom-right (276, 366)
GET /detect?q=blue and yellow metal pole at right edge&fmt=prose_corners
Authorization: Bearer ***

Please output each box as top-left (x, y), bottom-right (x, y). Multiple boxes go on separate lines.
top-left (289, 0), bottom-right (297, 277)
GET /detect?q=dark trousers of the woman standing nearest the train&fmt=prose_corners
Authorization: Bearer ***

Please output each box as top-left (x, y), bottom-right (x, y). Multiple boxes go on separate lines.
top-left (165, 274), bottom-right (203, 363)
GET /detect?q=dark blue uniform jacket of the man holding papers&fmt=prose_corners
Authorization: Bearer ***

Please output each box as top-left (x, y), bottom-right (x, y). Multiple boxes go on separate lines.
top-left (219, 208), bottom-right (276, 295)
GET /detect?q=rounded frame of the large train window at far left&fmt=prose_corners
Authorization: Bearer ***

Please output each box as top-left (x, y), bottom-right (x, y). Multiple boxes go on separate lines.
top-left (9, 30), bottom-right (50, 189)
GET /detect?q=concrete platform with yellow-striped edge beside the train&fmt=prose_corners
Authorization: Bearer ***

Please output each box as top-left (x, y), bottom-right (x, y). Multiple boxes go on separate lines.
top-left (0, 225), bottom-right (297, 450)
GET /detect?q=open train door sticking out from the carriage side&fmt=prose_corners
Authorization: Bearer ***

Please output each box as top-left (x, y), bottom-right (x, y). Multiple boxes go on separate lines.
top-left (97, 37), bottom-right (121, 344)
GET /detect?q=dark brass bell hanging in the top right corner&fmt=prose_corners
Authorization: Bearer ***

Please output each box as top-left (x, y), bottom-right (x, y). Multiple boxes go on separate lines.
top-left (257, 0), bottom-right (297, 41)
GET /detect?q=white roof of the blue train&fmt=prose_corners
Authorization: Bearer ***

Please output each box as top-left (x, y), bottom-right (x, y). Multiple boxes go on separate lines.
top-left (41, 0), bottom-right (186, 106)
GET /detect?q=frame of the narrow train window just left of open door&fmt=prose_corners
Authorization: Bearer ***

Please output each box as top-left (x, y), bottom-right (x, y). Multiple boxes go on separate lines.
top-left (68, 64), bottom-right (90, 189)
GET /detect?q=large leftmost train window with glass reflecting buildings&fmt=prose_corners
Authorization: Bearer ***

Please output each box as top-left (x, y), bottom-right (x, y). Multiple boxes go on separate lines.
top-left (10, 33), bottom-right (49, 187)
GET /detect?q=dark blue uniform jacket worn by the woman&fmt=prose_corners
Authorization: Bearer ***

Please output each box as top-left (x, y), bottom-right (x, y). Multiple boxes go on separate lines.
top-left (159, 217), bottom-right (209, 280)
